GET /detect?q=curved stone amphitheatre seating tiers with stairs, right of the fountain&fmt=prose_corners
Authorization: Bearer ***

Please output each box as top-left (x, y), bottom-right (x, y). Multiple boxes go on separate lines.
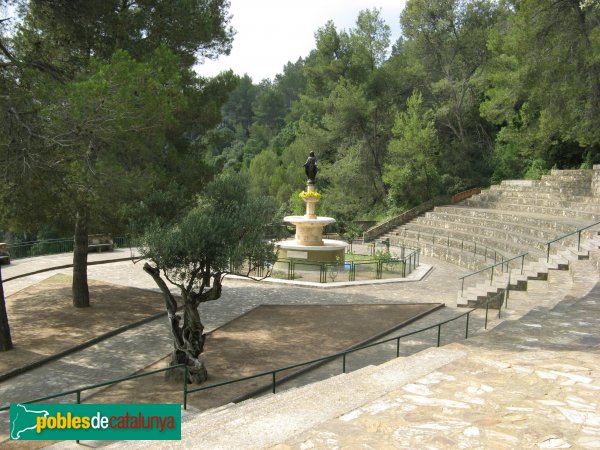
top-left (379, 166), bottom-right (600, 307)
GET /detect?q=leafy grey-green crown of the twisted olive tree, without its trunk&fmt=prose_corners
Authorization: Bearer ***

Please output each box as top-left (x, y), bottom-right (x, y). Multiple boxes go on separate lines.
top-left (141, 174), bottom-right (276, 282)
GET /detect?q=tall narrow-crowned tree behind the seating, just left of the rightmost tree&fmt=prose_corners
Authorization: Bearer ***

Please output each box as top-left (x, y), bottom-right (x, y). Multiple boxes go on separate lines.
top-left (397, 0), bottom-right (497, 190)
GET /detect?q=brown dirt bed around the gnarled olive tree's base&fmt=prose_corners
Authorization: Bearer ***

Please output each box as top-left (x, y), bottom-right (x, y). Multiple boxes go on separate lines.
top-left (86, 304), bottom-right (438, 410)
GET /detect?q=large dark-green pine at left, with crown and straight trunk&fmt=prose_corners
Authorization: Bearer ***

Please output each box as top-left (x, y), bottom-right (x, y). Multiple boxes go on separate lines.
top-left (1, 0), bottom-right (232, 306)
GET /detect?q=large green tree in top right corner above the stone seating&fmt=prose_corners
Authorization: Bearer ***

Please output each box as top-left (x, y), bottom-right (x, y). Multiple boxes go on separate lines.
top-left (481, 0), bottom-right (600, 176)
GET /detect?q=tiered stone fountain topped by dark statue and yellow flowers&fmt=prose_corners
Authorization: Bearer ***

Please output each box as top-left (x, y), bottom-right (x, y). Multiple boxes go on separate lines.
top-left (276, 152), bottom-right (346, 263)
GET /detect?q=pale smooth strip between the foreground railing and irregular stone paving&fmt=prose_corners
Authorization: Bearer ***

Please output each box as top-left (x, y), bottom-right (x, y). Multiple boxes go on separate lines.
top-left (111, 344), bottom-right (466, 449)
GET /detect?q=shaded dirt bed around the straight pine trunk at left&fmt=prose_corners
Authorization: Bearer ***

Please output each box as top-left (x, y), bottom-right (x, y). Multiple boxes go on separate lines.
top-left (0, 274), bottom-right (165, 374)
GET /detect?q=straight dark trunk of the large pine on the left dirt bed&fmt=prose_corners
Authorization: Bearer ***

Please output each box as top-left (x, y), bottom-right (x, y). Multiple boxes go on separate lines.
top-left (72, 213), bottom-right (90, 308)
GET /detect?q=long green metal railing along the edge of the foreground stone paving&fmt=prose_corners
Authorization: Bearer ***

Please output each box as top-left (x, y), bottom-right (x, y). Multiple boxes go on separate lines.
top-left (0, 299), bottom-right (501, 412)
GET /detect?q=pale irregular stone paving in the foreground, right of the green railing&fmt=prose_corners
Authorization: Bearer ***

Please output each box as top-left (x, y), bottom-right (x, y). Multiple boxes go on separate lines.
top-left (103, 255), bottom-right (600, 450)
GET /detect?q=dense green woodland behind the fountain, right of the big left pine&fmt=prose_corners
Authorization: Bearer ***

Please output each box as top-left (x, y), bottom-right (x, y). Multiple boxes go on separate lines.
top-left (202, 0), bottom-right (600, 220)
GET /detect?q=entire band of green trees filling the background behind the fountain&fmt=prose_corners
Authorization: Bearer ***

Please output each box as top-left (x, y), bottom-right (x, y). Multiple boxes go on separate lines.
top-left (0, 0), bottom-right (600, 241)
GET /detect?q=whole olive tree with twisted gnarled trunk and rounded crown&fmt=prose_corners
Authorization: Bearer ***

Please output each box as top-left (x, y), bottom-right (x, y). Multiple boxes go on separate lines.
top-left (141, 175), bottom-right (275, 383)
